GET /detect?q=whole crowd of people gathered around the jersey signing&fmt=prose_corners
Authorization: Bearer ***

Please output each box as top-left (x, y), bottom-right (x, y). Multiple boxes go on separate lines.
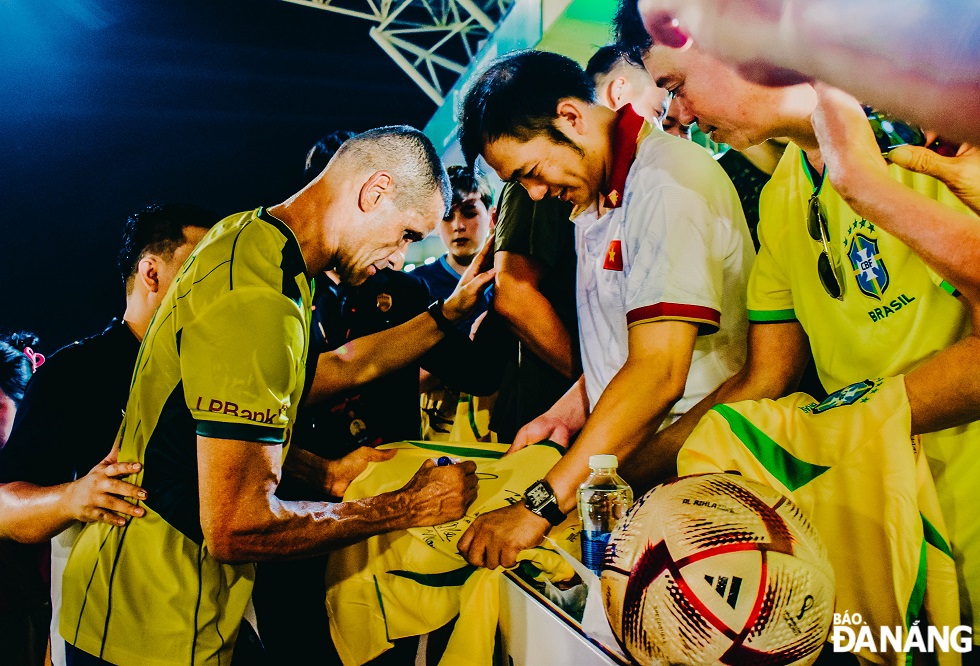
top-left (0, 0), bottom-right (980, 666)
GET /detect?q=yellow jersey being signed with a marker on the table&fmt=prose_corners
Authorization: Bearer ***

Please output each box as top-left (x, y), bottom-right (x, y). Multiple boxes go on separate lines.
top-left (326, 442), bottom-right (581, 666)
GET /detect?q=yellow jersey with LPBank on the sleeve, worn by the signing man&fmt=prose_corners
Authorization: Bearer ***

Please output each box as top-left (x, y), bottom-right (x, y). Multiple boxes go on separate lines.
top-left (60, 209), bottom-right (311, 666)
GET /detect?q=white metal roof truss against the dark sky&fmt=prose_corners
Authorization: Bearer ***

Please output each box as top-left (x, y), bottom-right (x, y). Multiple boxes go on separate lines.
top-left (285, 0), bottom-right (516, 106)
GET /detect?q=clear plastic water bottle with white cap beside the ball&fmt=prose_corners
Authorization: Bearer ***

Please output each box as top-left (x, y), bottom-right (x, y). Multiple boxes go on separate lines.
top-left (578, 455), bottom-right (633, 575)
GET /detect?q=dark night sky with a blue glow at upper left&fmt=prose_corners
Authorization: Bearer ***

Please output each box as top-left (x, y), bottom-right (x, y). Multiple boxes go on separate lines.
top-left (0, 0), bottom-right (435, 353)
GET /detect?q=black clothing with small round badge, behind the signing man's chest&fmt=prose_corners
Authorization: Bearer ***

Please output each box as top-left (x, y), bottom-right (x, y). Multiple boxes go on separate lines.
top-left (252, 269), bottom-right (429, 663)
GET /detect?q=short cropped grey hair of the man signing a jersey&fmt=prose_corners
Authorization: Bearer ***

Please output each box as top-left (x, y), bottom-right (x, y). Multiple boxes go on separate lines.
top-left (334, 125), bottom-right (452, 218)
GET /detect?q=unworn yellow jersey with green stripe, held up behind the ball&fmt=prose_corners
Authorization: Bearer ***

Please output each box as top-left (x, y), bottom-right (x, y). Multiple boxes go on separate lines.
top-left (677, 376), bottom-right (960, 665)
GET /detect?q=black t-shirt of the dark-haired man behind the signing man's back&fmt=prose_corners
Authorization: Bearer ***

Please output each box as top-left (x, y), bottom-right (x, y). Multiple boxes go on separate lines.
top-left (0, 319), bottom-right (139, 608)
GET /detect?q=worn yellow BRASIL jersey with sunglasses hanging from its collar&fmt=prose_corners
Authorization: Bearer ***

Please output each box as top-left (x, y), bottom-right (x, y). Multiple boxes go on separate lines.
top-left (748, 144), bottom-right (969, 391)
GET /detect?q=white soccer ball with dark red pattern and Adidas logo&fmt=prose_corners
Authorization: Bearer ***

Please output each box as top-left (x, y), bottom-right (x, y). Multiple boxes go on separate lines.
top-left (602, 474), bottom-right (834, 666)
